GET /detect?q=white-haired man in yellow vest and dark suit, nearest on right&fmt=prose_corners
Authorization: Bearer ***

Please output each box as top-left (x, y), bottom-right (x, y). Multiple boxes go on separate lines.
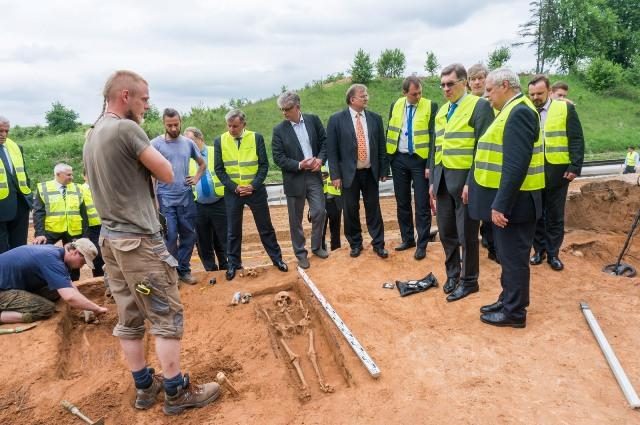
top-left (469, 68), bottom-right (544, 328)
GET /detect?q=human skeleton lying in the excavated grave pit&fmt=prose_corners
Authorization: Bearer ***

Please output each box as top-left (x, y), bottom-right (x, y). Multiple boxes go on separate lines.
top-left (261, 291), bottom-right (334, 400)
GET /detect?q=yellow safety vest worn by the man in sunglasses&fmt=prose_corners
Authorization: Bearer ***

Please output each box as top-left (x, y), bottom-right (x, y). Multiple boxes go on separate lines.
top-left (435, 94), bottom-right (480, 170)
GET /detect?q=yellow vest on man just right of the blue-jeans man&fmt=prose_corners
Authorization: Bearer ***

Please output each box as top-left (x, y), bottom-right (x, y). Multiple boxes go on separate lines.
top-left (220, 131), bottom-right (258, 185)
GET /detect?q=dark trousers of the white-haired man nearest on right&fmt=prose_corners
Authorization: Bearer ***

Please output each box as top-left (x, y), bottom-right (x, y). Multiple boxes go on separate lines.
top-left (493, 221), bottom-right (536, 319)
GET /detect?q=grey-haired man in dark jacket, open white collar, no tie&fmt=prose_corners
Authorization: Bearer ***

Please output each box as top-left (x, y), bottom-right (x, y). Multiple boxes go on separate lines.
top-left (271, 91), bottom-right (329, 269)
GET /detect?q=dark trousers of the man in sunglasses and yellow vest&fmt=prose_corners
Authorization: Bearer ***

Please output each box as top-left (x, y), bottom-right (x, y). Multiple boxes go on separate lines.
top-left (436, 177), bottom-right (480, 286)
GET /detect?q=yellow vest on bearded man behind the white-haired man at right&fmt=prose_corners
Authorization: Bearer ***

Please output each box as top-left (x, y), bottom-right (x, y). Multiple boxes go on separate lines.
top-left (544, 100), bottom-right (571, 164)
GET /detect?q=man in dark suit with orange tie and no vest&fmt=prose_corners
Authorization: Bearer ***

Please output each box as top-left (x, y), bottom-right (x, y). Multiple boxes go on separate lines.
top-left (327, 84), bottom-right (389, 258)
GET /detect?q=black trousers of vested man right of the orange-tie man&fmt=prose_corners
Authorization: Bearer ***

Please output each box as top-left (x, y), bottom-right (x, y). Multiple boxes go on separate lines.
top-left (391, 152), bottom-right (431, 248)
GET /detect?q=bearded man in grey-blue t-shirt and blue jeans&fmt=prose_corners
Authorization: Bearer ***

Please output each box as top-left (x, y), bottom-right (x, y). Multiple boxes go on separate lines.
top-left (151, 108), bottom-right (207, 285)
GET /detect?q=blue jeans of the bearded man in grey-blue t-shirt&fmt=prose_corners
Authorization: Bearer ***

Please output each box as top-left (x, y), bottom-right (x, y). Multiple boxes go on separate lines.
top-left (158, 198), bottom-right (197, 276)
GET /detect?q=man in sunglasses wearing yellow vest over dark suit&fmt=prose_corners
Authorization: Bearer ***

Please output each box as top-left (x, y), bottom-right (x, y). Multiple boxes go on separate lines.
top-left (429, 63), bottom-right (494, 301)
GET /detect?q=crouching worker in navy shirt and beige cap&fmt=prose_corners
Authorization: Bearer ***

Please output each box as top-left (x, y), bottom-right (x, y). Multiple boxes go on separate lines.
top-left (0, 238), bottom-right (107, 324)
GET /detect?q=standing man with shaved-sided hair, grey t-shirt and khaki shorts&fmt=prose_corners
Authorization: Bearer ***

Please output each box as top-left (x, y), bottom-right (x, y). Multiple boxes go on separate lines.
top-left (83, 71), bottom-right (220, 415)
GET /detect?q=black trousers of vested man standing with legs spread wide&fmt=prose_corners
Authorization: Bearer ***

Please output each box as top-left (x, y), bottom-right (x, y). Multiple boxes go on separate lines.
top-left (224, 186), bottom-right (282, 267)
